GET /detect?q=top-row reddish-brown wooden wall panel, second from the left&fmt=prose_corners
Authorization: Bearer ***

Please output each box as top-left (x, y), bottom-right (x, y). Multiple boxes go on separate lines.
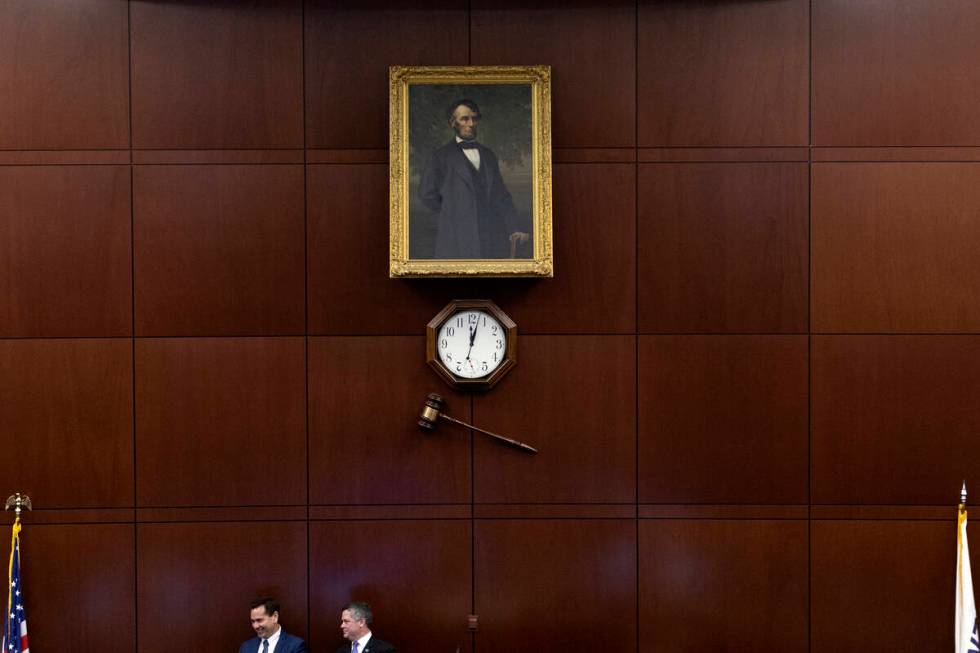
top-left (130, 0), bottom-right (303, 148)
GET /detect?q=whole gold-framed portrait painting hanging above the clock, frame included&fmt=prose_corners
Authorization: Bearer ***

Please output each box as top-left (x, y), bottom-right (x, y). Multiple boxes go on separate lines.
top-left (389, 66), bottom-right (554, 278)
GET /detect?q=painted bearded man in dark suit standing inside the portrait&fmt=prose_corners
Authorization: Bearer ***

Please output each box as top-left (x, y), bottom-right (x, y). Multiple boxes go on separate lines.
top-left (419, 99), bottom-right (529, 259)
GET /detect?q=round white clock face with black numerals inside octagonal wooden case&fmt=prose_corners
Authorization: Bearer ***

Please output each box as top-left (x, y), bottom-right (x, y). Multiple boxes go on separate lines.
top-left (436, 309), bottom-right (507, 379)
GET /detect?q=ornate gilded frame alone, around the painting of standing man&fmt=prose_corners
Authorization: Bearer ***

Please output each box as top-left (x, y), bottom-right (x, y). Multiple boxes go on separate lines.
top-left (388, 66), bottom-right (554, 278)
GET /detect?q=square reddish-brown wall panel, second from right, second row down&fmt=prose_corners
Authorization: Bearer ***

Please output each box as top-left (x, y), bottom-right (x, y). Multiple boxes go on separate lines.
top-left (637, 163), bottom-right (807, 333)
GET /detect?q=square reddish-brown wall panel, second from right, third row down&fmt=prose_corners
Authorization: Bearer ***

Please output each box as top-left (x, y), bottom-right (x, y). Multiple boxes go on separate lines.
top-left (637, 336), bottom-right (808, 504)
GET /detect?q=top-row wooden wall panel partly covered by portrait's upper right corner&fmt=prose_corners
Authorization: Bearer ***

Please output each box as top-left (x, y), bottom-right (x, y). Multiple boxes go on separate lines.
top-left (470, 0), bottom-right (636, 147)
